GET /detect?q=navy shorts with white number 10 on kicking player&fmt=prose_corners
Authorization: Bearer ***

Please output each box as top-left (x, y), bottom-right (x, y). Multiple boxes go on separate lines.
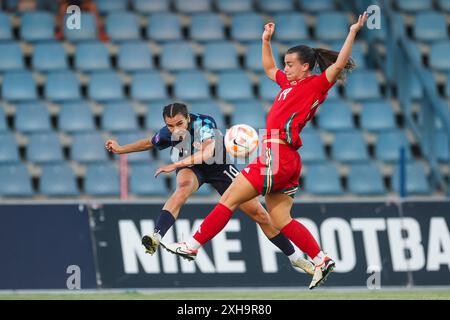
top-left (177, 164), bottom-right (239, 195)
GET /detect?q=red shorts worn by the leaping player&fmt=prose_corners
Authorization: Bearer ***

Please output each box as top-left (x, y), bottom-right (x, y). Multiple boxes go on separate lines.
top-left (241, 142), bottom-right (302, 198)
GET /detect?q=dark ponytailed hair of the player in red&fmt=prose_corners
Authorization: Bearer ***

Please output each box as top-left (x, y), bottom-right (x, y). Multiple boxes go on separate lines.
top-left (286, 45), bottom-right (356, 80)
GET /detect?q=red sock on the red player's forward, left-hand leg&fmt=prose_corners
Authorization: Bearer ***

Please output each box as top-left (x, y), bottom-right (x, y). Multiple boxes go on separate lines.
top-left (194, 203), bottom-right (233, 245)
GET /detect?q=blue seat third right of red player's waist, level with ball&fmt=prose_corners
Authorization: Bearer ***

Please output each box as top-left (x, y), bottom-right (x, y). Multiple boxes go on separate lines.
top-left (375, 130), bottom-right (411, 162)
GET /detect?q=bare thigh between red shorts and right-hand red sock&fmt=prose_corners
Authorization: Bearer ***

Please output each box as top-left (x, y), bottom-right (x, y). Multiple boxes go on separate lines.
top-left (266, 192), bottom-right (294, 229)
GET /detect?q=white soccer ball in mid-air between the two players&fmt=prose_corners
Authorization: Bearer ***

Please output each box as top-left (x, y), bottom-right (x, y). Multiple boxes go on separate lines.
top-left (225, 124), bottom-right (259, 158)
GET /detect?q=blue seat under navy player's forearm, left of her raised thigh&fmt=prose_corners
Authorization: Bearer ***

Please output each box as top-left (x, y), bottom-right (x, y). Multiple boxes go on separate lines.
top-left (130, 163), bottom-right (169, 196)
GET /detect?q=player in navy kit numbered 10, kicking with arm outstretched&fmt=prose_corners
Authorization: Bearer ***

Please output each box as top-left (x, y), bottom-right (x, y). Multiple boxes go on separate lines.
top-left (105, 103), bottom-right (314, 275)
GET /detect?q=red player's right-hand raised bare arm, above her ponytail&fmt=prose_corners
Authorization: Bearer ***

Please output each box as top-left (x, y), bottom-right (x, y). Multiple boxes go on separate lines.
top-left (325, 11), bottom-right (368, 83)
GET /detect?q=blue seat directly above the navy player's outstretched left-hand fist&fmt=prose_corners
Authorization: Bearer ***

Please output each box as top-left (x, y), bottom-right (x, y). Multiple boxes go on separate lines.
top-left (101, 101), bottom-right (138, 132)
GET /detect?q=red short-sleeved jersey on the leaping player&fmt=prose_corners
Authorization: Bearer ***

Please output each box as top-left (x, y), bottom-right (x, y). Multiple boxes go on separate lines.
top-left (266, 70), bottom-right (334, 149)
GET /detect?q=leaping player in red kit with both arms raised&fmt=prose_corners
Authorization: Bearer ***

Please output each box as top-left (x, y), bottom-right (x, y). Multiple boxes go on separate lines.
top-left (164, 12), bottom-right (368, 289)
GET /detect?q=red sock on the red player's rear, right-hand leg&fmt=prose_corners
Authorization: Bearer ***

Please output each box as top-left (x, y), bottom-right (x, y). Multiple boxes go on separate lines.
top-left (281, 219), bottom-right (320, 259)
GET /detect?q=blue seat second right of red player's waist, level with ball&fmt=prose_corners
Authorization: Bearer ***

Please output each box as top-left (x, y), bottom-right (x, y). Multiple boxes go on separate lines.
top-left (331, 130), bottom-right (369, 163)
